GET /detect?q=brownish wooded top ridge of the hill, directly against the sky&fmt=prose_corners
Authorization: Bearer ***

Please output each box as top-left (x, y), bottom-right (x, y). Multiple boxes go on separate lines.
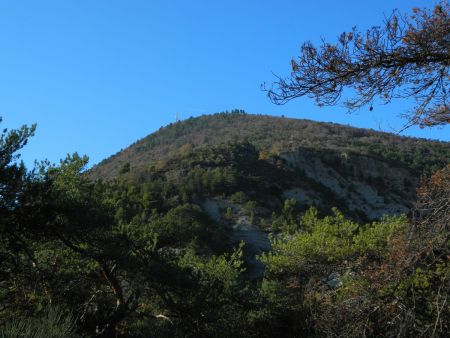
top-left (91, 110), bottom-right (450, 179)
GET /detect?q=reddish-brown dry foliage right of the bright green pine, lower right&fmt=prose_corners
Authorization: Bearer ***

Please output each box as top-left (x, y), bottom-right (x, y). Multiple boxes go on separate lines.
top-left (306, 165), bottom-right (450, 337)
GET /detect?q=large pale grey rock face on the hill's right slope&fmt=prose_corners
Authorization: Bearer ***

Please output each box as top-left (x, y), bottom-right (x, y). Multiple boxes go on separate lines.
top-left (280, 148), bottom-right (418, 220)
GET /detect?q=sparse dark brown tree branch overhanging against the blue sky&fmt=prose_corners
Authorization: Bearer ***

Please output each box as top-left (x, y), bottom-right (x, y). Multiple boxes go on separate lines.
top-left (263, 0), bottom-right (450, 128)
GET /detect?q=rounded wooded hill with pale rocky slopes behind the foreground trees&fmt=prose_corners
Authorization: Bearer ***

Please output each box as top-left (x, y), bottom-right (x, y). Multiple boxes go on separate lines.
top-left (90, 111), bottom-right (450, 257)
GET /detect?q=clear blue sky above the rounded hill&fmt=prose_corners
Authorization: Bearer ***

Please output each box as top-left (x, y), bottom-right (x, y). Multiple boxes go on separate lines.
top-left (0, 0), bottom-right (450, 168)
